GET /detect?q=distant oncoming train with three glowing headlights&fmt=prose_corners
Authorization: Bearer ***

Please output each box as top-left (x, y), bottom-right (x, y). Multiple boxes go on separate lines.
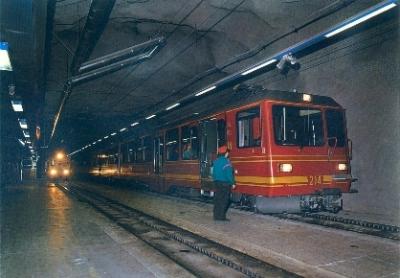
top-left (45, 151), bottom-right (71, 180)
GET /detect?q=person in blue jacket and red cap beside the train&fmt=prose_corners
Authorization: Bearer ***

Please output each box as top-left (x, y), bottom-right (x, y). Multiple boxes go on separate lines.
top-left (212, 146), bottom-right (235, 221)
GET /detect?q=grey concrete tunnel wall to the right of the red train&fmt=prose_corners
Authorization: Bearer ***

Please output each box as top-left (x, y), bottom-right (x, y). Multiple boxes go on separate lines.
top-left (256, 9), bottom-right (400, 217)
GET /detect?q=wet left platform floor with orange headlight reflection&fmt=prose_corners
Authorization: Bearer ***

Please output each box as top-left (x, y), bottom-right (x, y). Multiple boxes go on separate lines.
top-left (0, 182), bottom-right (191, 278)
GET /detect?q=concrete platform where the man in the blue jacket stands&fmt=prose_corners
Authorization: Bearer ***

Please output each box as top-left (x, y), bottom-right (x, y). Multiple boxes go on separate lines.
top-left (81, 183), bottom-right (400, 278)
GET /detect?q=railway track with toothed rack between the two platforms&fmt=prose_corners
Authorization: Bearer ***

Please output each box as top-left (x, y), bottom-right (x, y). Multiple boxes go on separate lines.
top-left (58, 184), bottom-right (299, 277)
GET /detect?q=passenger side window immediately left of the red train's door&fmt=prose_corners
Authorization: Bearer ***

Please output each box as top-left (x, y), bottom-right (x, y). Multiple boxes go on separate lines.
top-left (181, 126), bottom-right (199, 160)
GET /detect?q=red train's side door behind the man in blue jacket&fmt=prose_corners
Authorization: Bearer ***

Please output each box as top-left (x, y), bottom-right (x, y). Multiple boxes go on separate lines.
top-left (200, 119), bottom-right (226, 191)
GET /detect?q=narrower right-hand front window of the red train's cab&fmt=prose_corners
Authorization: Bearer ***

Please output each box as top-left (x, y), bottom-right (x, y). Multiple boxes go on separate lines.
top-left (325, 110), bottom-right (346, 147)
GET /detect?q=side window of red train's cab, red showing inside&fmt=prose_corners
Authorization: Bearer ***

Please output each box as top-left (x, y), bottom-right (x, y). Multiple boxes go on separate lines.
top-left (236, 106), bottom-right (261, 148)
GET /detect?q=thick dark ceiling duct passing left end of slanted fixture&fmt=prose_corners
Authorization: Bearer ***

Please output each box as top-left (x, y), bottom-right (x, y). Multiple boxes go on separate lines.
top-left (50, 0), bottom-right (115, 140)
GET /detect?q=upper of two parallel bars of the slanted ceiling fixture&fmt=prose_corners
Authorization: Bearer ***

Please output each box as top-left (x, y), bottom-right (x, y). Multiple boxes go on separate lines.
top-left (78, 37), bottom-right (165, 74)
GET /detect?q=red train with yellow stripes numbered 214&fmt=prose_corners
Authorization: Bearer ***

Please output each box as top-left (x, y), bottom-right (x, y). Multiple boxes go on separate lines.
top-left (80, 91), bottom-right (352, 212)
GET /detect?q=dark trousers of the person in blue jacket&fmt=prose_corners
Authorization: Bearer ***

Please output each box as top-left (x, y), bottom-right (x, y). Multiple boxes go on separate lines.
top-left (214, 181), bottom-right (231, 220)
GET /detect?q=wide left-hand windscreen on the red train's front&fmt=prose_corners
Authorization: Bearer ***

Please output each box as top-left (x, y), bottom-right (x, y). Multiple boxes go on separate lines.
top-left (272, 105), bottom-right (324, 147)
